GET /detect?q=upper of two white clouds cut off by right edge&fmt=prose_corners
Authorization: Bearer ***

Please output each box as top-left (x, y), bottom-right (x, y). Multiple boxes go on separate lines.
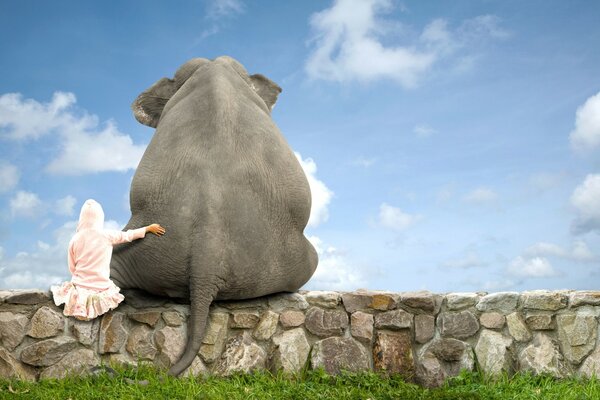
top-left (569, 92), bottom-right (600, 152)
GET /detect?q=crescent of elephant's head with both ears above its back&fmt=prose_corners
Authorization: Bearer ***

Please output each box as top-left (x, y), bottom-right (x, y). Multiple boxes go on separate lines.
top-left (131, 56), bottom-right (281, 128)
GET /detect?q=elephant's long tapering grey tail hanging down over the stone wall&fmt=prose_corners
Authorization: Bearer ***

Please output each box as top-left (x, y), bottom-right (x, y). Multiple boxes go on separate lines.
top-left (169, 264), bottom-right (219, 376)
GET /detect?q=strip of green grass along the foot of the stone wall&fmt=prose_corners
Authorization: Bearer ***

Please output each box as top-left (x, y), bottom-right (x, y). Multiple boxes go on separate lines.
top-left (0, 367), bottom-right (600, 400)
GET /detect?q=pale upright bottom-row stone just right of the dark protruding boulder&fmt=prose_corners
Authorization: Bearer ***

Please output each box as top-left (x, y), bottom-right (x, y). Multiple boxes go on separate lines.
top-left (475, 329), bottom-right (514, 375)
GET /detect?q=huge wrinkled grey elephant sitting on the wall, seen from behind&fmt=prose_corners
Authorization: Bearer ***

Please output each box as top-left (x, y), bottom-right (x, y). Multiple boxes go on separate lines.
top-left (111, 57), bottom-right (317, 375)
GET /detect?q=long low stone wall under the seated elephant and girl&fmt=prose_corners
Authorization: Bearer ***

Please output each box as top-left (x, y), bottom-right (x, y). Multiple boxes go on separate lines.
top-left (0, 290), bottom-right (600, 386)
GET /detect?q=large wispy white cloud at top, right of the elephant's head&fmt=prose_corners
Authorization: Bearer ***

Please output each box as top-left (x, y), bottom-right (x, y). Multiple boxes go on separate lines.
top-left (305, 0), bottom-right (507, 88)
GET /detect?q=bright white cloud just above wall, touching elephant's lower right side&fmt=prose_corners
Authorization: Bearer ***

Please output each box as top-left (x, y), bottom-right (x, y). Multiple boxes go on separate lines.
top-left (303, 236), bottom-right (368, 290)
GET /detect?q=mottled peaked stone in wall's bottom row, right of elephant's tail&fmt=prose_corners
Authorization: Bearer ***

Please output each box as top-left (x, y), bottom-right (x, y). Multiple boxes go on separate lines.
top-left (215, 332), bottom-right (267, 376)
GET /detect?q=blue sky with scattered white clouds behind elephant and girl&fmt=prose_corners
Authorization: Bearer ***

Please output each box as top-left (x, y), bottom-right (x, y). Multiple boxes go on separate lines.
top-left (0, 0), bottom-right (600, 292)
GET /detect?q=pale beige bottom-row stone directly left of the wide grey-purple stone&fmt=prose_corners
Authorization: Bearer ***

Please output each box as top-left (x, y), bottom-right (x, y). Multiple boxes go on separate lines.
top-left (273, 328), bottom-right (310, 372)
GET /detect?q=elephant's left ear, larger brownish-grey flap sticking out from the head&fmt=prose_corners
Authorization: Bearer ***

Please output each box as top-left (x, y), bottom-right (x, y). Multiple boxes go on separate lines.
top-left (131, 78), bottom-right (179, 128)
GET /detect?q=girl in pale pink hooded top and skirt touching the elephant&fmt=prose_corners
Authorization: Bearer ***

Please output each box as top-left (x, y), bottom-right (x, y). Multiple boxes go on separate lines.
top-left (50, 199), bottom-right (165, 321)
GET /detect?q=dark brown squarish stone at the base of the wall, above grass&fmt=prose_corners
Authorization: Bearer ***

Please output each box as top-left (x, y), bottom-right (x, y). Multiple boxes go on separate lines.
top-left (373, 330), bottom-right (415, 380)
